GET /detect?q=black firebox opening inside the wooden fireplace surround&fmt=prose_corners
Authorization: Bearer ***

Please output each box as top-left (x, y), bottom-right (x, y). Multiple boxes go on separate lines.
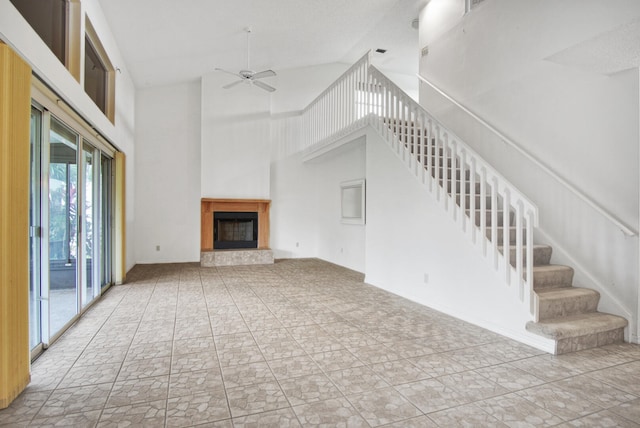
top-left (213, 211), bottom-right (258, 250)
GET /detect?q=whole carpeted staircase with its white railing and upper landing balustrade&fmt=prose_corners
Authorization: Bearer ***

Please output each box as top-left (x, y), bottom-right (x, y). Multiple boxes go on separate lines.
top-left (295, 54), bottom-right (627, 354)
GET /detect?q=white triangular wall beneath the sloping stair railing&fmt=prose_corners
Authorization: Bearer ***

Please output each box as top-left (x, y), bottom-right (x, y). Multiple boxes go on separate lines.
top-left (365, 128), bottom-right (555, 353)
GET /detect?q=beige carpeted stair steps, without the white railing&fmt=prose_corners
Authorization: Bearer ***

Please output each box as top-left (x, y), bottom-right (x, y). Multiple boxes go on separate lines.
top-left (385, 120), bottom-right (627, 354)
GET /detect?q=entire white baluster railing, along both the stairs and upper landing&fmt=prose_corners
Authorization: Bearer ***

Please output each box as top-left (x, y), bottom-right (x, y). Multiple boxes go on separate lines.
top-left (301, 53), bottom-right (538, 321)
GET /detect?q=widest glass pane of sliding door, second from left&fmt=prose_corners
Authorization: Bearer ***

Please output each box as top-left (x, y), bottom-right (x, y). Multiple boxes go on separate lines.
top-left (49, 117), bottom-right (79, 337)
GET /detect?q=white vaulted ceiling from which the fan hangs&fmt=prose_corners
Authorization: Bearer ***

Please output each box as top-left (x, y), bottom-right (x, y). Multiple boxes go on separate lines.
top-left (99, 0), bottom-right (428, 86)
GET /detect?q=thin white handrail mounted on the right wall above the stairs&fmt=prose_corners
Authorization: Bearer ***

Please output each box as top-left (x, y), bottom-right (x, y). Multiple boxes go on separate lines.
top-left (417, 74), bottom-right (638, 236)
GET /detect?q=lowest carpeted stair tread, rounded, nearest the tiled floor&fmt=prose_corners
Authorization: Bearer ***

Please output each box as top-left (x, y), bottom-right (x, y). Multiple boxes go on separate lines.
top-left (527, 312), bottom-right (627, 340)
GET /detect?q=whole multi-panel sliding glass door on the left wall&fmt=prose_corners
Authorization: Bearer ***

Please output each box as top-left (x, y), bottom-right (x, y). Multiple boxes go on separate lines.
top-left (29, 101), bottom-right (112, 354)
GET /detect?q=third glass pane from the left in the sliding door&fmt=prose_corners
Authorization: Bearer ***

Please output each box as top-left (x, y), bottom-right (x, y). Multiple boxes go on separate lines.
top-left (80, 143), bottom-right (95, 308)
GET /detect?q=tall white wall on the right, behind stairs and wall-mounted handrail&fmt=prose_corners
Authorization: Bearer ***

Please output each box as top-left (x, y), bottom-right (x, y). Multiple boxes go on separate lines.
top-left (420, 0), bottom-right (640, 340)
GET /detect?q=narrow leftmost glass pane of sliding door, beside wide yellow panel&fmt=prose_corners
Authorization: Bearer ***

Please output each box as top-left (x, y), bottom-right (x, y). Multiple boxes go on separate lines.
top-left (29, 107), bottom-right (42, 351)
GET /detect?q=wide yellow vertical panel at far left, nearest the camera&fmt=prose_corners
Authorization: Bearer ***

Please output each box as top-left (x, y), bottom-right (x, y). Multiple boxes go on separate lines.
top-left (0, 43), bottom-right (31, 409)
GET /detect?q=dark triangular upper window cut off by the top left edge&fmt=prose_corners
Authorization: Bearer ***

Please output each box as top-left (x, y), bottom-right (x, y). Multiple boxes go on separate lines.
top-left (11, 0), bottom-right (67, 64)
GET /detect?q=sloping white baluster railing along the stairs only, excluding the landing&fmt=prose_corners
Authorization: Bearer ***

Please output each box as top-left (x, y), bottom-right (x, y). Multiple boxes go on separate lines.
top-left (367, 65), bottom-right (538, 314)
